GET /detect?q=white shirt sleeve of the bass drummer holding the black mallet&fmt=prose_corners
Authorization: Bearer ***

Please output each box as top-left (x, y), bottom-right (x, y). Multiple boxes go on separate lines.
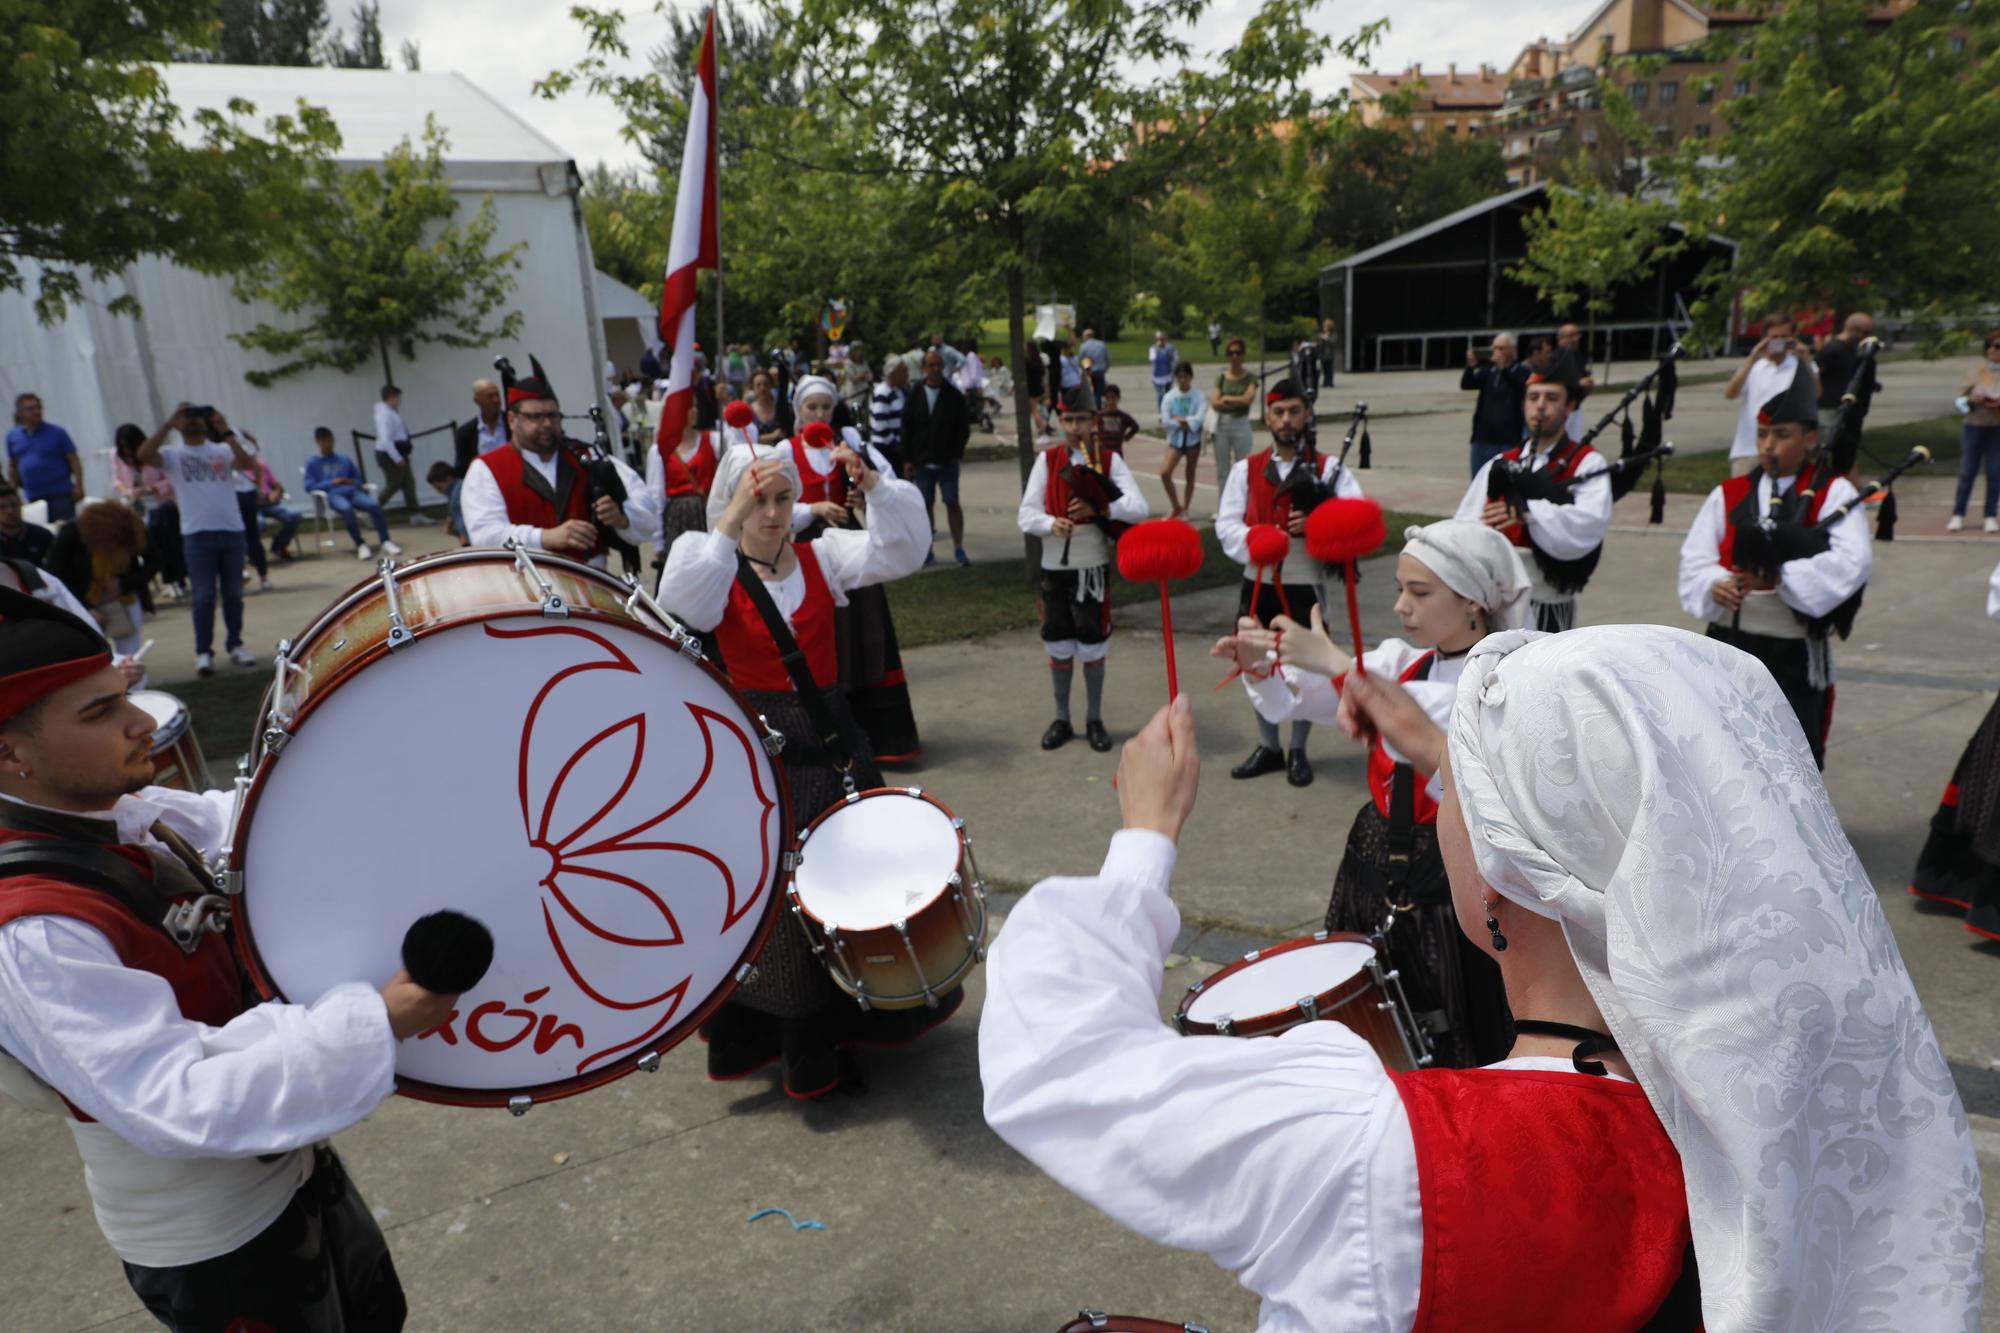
top-left (0, 917), bottom-right (396, 1157)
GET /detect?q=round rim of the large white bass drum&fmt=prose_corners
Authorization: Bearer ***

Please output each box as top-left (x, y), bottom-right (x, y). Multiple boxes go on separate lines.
top-left (230, 546), bottom-right (792, 1109)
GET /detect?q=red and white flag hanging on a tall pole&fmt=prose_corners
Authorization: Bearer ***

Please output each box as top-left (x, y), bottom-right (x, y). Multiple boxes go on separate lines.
top-left (658, 8), bottom-right (722, 454)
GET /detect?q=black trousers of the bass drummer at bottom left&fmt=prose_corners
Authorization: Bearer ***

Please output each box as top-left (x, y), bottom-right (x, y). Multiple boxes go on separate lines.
top-left (124, 1145), bottom-right (408, 1333)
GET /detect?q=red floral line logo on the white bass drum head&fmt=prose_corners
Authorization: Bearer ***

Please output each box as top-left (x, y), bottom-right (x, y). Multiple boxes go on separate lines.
top-left (484, 624), bottom-right (780, 1073)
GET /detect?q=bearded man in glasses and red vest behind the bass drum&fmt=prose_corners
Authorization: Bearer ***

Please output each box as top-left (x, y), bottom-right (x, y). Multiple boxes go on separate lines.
top-left (458, 358), bottom-right (666, 566)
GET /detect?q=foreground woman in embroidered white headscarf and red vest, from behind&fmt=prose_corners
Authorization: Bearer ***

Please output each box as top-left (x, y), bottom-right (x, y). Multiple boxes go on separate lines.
top-left (980, 624), bottom-right (1984, 1333)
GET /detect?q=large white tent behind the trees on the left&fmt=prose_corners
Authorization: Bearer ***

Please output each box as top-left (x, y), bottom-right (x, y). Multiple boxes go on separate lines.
top-left (0, 64), bottom-right (606, 498)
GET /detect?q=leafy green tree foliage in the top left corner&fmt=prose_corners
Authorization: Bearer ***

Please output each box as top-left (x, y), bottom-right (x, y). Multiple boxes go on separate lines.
top-left (0, 0), bottom-right (340, 322)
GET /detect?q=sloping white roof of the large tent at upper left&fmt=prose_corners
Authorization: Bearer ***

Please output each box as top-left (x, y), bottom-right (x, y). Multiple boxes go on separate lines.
top-left (162, 64), bottom-right (570, 166)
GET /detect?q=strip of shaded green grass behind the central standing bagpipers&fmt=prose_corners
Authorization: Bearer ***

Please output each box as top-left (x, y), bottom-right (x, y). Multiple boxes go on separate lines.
top-left (888, 510), bottom-right (1438, 648)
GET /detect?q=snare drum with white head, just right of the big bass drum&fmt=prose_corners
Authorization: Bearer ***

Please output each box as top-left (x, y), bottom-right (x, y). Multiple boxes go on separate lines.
top-left (790, 787), bottom-right (986, 1009)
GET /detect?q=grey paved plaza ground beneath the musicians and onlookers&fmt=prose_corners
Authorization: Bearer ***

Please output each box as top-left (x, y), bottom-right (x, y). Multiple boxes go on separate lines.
top-left (0, 352), bottom-right (2000, 1333)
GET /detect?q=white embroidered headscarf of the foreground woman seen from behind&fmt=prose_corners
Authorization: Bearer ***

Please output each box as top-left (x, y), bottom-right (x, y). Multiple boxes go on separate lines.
top-left (1450, 624), bottom-right (1984, 1333)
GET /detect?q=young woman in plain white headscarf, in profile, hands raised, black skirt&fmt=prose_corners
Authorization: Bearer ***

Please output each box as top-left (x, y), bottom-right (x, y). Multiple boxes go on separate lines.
top-left (1214, 522), bottom-right (1530, 1069)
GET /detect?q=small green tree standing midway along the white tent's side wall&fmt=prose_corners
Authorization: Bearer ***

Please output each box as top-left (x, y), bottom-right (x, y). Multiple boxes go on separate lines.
top-left (230, 122), bottom-right (524, 388)
